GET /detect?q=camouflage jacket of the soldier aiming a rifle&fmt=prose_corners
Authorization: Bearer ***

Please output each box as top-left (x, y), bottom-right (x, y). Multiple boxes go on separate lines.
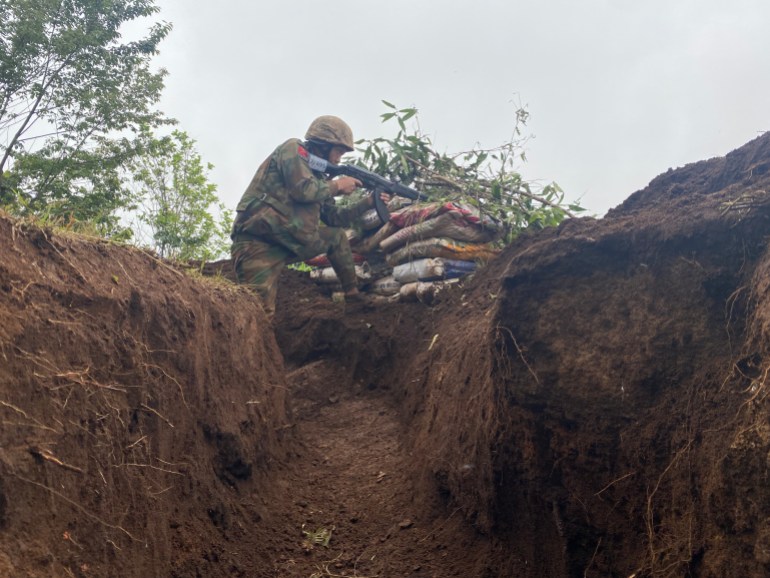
top-left (233, 139), bottom-right (369, 244)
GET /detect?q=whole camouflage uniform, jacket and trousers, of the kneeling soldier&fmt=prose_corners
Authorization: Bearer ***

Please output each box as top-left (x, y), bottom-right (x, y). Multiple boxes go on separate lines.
top-left (231, 139), bottom-right (369, 315)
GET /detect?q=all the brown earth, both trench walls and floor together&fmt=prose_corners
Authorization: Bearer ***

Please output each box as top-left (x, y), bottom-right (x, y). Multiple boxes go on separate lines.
top-left (0, 135), bottom-right (770, 578)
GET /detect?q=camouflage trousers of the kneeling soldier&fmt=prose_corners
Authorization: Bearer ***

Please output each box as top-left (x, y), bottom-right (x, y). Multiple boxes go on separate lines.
top-left (230, 227), bottom-right (357, 316)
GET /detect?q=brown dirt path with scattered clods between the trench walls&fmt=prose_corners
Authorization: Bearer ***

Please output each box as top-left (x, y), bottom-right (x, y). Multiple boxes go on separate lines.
top-left (266, 361), bottom-right (510, 578)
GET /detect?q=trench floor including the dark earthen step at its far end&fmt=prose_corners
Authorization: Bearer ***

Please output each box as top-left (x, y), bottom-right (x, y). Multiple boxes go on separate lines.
top-left (258, 316), bottom-right (525, 578)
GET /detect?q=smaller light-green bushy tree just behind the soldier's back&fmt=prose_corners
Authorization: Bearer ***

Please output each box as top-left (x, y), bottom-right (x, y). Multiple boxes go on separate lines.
top-left (131, 127), bottom-right (232, 260)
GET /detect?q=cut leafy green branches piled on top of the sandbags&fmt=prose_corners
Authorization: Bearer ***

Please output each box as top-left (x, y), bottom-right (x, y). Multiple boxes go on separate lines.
top-left (357, 101), bottom-right (584, 242)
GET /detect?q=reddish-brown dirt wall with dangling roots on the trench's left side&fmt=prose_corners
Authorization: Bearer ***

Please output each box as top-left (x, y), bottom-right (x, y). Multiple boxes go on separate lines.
top-left (0, 216), bottom-right (290, 577)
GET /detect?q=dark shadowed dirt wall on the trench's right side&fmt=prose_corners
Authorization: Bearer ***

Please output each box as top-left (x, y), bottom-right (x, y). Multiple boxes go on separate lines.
top-left (396, 137), bottom-right (770, 577)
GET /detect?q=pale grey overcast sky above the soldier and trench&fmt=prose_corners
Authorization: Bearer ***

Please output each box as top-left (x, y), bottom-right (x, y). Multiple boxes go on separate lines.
top-left (138, 0), bottom-right (770, 216)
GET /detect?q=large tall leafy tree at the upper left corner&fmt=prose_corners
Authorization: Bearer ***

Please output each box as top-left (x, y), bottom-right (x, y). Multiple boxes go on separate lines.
top-left (0, 0), bottom-right (170, 228)
